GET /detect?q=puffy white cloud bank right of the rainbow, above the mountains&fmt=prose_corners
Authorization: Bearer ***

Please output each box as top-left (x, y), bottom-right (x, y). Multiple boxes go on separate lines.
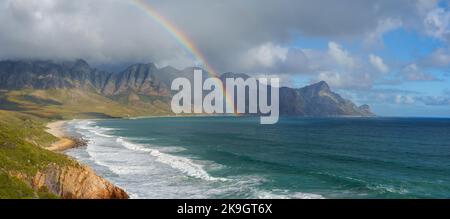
top-left (243, 41), bottom-right (388, 89)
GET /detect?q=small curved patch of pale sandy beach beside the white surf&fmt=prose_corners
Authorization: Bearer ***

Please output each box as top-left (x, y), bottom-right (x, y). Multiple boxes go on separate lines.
top-left (46, 121), bottom-right (78, 152)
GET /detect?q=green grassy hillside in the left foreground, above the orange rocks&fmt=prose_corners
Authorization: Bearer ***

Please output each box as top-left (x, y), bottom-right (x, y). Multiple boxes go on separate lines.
top-left (0, 110), bottom-right (76, 198)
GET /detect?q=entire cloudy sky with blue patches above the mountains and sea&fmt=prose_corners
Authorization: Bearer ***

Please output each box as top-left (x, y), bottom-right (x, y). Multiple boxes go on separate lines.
top-left (0, 0), bottom-right (450, 117)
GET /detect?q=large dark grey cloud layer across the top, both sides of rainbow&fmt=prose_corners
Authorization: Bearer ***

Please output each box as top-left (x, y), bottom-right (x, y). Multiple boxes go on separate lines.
top-left (0, 0), bottom-right (442, 73)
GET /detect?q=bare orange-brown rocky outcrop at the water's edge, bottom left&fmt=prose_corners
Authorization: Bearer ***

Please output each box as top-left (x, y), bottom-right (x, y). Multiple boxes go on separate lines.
top-left (31, 164), bottom-right (129, 199)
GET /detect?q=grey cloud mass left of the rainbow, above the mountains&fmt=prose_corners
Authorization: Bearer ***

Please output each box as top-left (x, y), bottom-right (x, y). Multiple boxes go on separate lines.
top-left (0, 0), bottom-right (193, 66)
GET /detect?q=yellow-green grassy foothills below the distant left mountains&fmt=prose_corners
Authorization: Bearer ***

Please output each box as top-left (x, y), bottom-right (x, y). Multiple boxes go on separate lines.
top-left (0, 89), bottom-right (169, 119)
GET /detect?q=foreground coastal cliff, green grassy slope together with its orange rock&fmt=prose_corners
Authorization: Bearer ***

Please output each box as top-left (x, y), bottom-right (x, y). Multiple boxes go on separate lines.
top-left (0, 110), bottom-right (129, 199)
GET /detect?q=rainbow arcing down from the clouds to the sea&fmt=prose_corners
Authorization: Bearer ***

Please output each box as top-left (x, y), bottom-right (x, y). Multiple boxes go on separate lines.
top-left (131, 0), bottom-right (235, 113)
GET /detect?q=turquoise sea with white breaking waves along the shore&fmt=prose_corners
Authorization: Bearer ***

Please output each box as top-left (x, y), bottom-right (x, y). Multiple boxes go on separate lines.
top-left (68, 117), bottom-right (450, 198)
